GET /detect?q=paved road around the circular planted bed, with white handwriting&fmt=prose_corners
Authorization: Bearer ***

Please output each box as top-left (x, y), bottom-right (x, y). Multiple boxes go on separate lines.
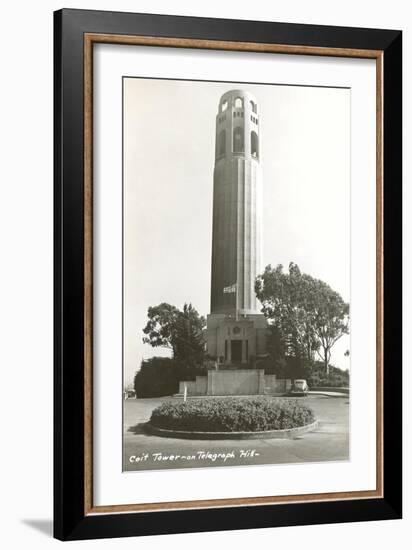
top-left (123, 395), bottom-right (349, 471)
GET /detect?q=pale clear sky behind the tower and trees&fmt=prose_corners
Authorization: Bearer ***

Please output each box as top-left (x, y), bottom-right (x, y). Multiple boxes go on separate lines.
top-left (123, 78), bottom-right (350, 383)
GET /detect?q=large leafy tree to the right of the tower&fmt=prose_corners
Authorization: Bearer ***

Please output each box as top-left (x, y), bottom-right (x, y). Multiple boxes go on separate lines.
top-left (255, 263), bottom-right (349, 373)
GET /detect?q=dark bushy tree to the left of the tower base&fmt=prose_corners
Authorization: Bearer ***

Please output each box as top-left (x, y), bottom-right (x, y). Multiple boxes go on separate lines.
top-left (143, 303), bottom-right (206, 366)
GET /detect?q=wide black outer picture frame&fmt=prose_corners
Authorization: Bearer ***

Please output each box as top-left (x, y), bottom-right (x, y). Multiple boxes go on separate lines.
top-left (54, 9), bottom-right (402, 540)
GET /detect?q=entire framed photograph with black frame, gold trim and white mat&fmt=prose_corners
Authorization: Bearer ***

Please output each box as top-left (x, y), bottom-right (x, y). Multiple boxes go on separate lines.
top-left (54, 9), bottom-right (402, 540)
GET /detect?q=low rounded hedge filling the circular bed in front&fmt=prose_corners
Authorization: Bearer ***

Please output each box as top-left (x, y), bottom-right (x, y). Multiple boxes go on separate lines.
top-left (150, 397), bottom-right (315, 432)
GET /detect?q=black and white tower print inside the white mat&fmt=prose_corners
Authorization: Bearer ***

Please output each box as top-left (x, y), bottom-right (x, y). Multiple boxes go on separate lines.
top-left (123, 76), bottom-right (350, 472)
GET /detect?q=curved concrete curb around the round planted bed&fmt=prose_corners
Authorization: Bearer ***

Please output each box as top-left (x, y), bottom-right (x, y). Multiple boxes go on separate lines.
top-left (145, 420), bottom-right (318, 439)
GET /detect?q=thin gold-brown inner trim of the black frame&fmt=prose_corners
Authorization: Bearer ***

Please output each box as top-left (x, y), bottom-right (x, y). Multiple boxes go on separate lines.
top-left (84, 33), bottom-right (384, 515)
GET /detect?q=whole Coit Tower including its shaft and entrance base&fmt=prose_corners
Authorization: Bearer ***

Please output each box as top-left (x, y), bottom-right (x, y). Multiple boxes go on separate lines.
top-left (207, 90), bottom-right (266, 363)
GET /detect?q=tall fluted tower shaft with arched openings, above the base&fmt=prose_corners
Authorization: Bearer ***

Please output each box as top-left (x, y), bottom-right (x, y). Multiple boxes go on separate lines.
top-left (211, 90), bottom-right (262, 314)
